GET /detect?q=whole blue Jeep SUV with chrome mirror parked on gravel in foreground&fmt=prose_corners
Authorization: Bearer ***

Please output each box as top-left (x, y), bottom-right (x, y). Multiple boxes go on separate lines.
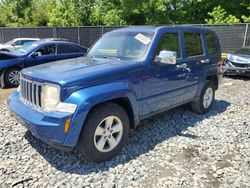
top-left (8, 26), bottom-right (220, 162)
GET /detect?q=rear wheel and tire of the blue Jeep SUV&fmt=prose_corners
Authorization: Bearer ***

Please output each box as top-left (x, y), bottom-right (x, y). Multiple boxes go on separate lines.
top-left (191, 81), bottom-right (215, 114)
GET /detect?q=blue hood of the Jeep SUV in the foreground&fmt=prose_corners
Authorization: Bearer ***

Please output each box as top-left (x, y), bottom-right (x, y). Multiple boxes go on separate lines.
top-left (22, 56), bottom-right (141, 87)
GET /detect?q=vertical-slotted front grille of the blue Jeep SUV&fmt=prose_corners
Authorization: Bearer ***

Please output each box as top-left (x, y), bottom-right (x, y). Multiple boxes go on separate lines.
top-left (20, 78), bottom-right (42, 108)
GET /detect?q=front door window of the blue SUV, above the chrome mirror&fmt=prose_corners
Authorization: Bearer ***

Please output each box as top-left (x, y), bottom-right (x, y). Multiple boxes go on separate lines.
top-left (156, 33), bottom-right (180, 58)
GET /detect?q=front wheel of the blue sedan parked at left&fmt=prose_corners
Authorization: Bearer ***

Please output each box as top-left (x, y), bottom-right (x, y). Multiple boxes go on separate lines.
top-left (4, 67), bottom-right (20, 87)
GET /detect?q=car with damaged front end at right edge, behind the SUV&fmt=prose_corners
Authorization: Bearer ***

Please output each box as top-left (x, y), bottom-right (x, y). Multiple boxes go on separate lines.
top-left (223, 46), bottom-right (250, 76)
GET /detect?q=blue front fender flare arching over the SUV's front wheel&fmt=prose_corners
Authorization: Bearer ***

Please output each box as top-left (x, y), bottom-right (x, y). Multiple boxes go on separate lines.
top-left (64, 82), bottom-right (139, 147)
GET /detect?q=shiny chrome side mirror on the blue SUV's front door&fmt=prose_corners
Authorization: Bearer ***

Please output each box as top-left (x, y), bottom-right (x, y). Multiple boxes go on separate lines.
top-left (155, 50), bottom-right (177, 64)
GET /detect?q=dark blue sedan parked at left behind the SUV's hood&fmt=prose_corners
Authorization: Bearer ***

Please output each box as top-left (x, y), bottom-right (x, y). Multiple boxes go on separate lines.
top-left (0, 40), bottom-right (87, 87)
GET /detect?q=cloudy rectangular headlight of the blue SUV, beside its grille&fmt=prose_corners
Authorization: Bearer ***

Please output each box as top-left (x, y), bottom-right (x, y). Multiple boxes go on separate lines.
top-left (42, 84), bottom-right (60, 112)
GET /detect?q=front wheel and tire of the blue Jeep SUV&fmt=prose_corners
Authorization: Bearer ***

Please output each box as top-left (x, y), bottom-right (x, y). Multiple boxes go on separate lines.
top-left (78, 103), bottom-right (129, 162)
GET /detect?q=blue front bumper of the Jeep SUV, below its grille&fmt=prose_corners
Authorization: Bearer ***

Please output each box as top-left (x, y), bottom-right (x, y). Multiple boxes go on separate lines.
top-left (8, 92), bottom-right (74, 151)
